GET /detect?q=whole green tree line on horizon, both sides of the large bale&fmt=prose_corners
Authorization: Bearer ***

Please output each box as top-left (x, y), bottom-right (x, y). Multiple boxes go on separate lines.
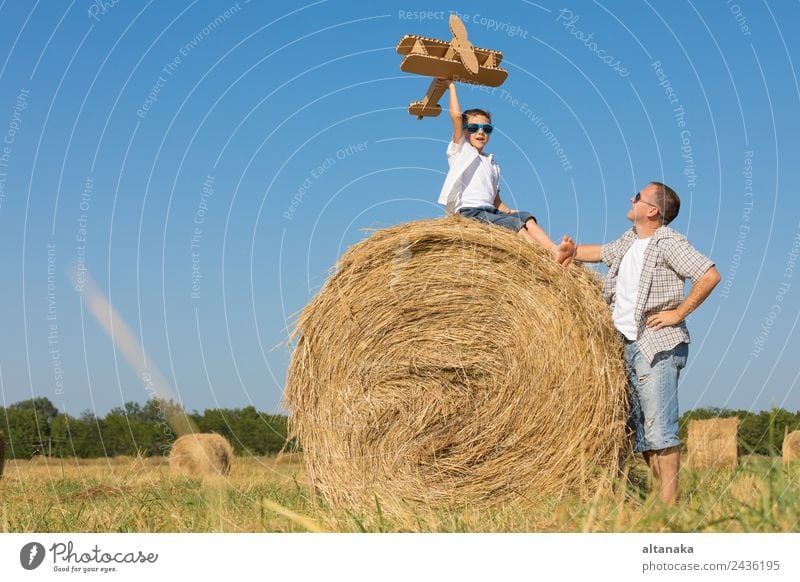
top-left (0, 397), bottom-right (800, 459)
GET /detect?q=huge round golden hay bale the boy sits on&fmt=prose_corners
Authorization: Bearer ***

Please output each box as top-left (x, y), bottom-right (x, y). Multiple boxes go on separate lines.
top-left (285, 217), bottom-right (627, 514)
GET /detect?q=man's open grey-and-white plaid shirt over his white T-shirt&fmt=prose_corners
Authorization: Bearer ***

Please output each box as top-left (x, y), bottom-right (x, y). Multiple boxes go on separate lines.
top-left (600, 226), bottom-right (714, 362)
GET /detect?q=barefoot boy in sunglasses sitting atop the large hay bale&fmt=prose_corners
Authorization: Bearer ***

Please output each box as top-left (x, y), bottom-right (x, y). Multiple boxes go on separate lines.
top-left (438, 79), bottom-right (576, 265)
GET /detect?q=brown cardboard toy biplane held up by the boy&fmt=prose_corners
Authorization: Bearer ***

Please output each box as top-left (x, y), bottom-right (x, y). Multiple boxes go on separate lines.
top-left (397, 14), bottom-right (508, 119)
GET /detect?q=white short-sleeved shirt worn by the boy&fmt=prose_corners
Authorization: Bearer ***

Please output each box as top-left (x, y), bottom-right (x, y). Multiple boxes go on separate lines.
top-left (439, 137), bottom-right (500, 214)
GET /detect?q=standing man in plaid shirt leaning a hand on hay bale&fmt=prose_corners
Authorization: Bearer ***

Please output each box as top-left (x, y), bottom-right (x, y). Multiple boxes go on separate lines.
top-left (575, 182), bottom-right (720, 503)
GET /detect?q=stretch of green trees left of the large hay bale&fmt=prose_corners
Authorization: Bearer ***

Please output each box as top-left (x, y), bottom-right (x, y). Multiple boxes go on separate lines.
top-left (0, 397), bottom-right (291, 459)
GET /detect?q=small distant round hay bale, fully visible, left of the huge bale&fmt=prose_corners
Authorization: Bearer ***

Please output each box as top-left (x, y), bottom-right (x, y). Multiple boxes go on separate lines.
top-left (169, 434), bottom-right (233, 477)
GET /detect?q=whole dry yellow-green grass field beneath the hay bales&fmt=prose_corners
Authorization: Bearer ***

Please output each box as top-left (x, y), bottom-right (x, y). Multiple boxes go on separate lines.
top-left (0, 455), bottom-right (800, 532)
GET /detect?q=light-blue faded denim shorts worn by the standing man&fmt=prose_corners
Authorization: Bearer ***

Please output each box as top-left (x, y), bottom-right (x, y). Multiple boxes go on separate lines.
top-left (625, 341), bottom-right (689, 453)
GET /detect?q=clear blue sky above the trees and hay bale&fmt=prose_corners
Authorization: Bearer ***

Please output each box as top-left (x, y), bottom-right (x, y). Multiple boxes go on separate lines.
top-left (0, 0), bottom-right (800, 414)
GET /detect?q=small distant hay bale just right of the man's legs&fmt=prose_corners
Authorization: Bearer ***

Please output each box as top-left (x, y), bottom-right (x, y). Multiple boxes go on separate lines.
top-left (686, 418), bottom-right (739, 469)
